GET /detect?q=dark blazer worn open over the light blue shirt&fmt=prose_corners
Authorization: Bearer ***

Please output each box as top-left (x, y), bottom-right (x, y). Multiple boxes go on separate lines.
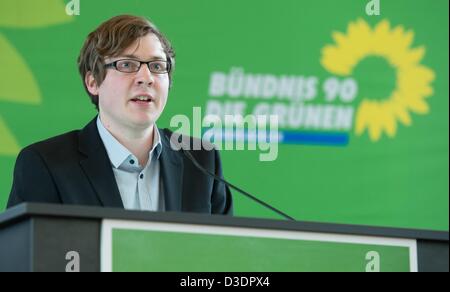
top-left (8, 118), bottom-right (233, 215)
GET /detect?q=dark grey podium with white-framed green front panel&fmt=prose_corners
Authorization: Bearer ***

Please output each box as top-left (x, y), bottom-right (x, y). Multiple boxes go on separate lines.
top-left (0, 203), bottom-right (449, 272)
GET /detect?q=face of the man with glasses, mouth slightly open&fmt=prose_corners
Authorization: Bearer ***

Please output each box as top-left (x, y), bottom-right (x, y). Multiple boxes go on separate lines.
top-left (87, 34), bottom-right (169, 130)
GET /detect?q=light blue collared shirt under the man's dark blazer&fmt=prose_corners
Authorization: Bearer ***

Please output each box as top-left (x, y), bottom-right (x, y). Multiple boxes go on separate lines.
top-left (97, 117), bottom-right (165, 211)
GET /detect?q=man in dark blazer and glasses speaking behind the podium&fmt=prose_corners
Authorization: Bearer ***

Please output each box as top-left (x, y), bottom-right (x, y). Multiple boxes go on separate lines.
top-left (8, 15), bottom-right (232, 215)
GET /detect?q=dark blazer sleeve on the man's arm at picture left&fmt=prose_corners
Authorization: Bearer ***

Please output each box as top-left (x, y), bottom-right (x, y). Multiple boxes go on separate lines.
top-left (7, 148), bottom-right (61, 208)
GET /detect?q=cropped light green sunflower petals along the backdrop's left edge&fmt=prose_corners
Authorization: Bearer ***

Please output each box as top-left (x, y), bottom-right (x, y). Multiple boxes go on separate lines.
top-left (0, 0), bottom-right (72, 156)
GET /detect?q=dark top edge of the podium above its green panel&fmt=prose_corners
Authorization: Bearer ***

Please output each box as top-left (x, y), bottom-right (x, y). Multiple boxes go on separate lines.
top-left (0, 203), bottom-right (449, 242)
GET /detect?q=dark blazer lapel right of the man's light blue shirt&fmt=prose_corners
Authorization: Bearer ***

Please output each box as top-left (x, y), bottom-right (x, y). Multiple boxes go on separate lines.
top-left (160, 130), bottom-right (183, 212)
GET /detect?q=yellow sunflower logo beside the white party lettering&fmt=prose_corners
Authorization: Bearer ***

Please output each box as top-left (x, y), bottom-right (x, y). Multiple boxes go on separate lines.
top-left (321, 19), bottom-right (435, 142)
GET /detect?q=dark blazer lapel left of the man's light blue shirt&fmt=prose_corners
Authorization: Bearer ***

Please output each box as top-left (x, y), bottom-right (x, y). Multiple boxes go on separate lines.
top-left (79, 117), bottom-right (124, 208)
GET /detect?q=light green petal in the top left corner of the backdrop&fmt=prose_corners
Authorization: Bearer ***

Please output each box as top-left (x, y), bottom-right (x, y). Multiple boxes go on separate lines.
top-left (0, 0), bottom-right (73, 28)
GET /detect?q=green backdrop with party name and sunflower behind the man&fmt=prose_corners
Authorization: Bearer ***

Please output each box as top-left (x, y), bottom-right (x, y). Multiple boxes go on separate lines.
top-left (0, 0), bottom-right (449, 230)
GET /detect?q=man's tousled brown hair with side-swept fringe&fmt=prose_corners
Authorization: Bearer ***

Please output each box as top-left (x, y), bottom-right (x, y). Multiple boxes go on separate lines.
top-left (77, 15), bottom-right (175, 110)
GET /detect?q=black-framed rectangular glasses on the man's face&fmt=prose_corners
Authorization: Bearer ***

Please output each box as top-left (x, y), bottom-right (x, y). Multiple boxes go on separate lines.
top-left (105, 59), bottom-right (171, 74)
